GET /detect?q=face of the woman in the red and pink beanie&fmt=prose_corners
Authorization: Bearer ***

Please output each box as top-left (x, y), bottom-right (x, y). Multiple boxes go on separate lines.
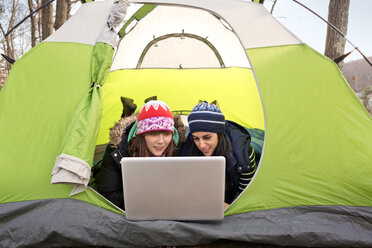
top-left (145, 131), bottom-right (172, 157)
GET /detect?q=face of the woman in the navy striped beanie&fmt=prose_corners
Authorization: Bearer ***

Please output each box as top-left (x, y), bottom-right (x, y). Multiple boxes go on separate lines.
top-left (192, 132), bottom-right (218, 156)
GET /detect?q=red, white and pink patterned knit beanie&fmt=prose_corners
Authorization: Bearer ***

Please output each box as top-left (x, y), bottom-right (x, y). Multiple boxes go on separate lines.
top-left (137, 100), bottom-right (174, 135)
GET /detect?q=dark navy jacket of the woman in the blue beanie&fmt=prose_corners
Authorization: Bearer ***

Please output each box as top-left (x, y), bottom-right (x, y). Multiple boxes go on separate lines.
top-left (178, 121), bottom-right (256, 204)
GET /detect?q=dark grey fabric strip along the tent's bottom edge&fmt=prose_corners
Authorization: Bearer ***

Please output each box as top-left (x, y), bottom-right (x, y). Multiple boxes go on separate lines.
top-left (0, 199), bottom-right (372, 247)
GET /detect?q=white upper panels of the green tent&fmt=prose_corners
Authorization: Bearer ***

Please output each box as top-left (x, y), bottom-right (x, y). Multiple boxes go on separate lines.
top-left (46, 0), bottom-right (302, 70)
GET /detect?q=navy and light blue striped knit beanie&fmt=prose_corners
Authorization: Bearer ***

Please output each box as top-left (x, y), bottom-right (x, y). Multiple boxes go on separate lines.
top-left (187, 101), bottom-right (225, 133)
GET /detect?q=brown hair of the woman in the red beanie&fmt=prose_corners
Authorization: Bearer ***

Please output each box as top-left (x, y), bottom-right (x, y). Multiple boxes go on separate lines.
top-left (128, 131), bottom-right (174, 157)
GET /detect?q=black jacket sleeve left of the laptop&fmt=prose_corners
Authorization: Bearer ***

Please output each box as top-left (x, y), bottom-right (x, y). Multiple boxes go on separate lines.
top-left (95, 144), bottom-right (124, 209)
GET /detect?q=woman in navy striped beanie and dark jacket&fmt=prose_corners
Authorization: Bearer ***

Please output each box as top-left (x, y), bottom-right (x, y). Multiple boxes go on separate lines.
top-left (179, 102), bottom-right (256, 204)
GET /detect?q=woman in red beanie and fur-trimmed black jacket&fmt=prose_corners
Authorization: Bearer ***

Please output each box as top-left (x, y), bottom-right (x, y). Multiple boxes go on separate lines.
top-left (92, 100), bottom-right (185, 209)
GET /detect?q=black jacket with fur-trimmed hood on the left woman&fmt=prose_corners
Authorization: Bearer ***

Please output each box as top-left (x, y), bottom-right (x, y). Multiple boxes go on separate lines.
top-left (92, 115), bottom-right (185, 209)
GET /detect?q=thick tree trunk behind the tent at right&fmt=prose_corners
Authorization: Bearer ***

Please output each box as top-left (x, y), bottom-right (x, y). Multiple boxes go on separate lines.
top-left (324, 0), bottom-right (350, 70)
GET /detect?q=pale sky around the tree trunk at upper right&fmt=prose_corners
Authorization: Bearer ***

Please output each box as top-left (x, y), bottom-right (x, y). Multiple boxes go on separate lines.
top-left (264, 0), bottom-right (372, 62)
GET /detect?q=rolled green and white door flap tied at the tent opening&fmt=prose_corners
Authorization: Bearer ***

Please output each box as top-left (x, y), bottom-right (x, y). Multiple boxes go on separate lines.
top-left (52, 1), bottom-right (128, 196)
